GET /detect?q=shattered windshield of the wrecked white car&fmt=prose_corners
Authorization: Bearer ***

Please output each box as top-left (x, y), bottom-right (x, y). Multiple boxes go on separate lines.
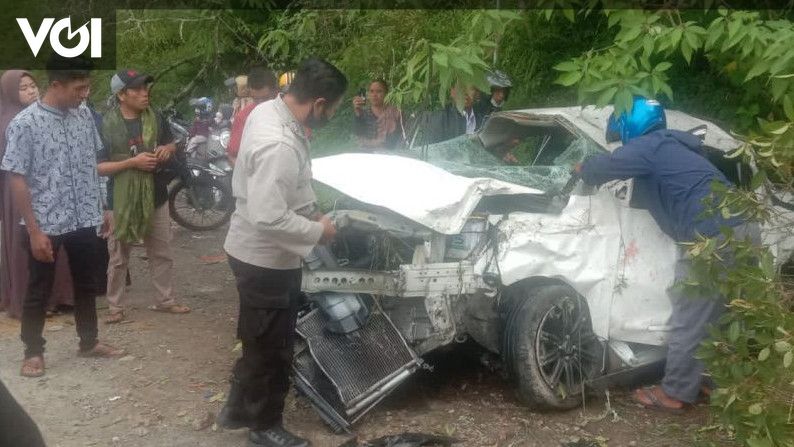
top-left (406, 135), bottom-right (603, 194)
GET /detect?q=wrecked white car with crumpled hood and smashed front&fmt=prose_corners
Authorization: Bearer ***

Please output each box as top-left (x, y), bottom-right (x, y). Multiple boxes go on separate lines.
top-left (294, 107), bottom-right (791, 430)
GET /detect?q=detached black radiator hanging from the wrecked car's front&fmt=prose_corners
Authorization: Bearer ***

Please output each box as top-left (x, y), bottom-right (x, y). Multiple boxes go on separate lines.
top-left (295, 309), bottom-right (419, 414)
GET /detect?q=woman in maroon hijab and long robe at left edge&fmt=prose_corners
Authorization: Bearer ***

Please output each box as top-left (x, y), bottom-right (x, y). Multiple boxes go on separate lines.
top-left (0, 70), bottom-right (74, 318)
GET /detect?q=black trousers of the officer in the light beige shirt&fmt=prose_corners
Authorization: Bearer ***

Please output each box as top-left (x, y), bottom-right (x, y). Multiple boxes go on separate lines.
top-left (226, 256), bottom-right (301, 430)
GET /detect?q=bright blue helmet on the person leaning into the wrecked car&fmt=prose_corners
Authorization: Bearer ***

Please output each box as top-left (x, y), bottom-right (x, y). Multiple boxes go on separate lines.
top-left (606, 96), bottom-right (667, 144)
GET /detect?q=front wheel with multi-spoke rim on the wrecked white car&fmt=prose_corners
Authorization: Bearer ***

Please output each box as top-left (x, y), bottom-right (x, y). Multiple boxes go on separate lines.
top-left (503, 284), bottom-right (604, 410)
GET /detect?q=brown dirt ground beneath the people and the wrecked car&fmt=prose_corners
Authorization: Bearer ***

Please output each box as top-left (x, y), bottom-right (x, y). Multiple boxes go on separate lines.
top-left (0, 226), bottom-right (730, 447)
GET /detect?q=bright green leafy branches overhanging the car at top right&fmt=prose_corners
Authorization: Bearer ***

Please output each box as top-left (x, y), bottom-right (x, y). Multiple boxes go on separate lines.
top-left (555, 9), bottom-right (794, 121)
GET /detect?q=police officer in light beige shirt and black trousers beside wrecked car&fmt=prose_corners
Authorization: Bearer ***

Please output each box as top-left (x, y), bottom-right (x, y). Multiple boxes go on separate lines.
top-left (218, 58), bottom-right (347, 447)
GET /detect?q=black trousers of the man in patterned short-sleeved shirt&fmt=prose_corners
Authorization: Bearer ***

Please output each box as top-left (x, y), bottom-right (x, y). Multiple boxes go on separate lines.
top-left (22, 227), bottom-right (99, 358)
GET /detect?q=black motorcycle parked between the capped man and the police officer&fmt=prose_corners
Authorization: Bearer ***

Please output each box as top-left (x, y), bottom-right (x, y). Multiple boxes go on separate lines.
top-left (167, 113), bottom-right (234, 231)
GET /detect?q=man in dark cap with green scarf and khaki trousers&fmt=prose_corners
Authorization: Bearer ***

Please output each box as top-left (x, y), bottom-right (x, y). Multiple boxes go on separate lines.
top-left (98, 70), bottom-right (190, 324)
